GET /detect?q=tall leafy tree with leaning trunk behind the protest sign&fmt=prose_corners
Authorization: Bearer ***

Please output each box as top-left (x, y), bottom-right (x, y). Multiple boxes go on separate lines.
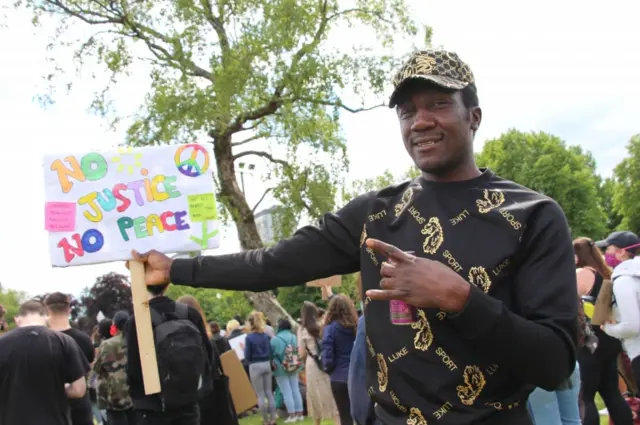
top-left (19, 0), bottom-right (420, 320)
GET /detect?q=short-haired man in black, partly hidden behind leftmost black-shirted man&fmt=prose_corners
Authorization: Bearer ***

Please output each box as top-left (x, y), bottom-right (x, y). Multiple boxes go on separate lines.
top-left (44, 292), bottom-right (95, 425)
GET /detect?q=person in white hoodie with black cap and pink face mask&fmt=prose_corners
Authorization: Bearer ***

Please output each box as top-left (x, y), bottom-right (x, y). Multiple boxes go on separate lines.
top-left (596, 231), bottom-right (640, 394)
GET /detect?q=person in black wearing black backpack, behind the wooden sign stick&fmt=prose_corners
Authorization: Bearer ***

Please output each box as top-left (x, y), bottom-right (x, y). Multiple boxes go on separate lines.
top-left (124, 284), bottom-right (213, 425)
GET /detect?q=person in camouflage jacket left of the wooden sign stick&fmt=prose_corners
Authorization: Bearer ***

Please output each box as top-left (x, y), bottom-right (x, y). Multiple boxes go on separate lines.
top-left (93, 311), bottom-right (136, 425)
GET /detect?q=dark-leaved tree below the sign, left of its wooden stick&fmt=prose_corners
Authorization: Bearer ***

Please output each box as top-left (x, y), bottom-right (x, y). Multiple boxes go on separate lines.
top-left (79, 272), bottom-right (133, 327)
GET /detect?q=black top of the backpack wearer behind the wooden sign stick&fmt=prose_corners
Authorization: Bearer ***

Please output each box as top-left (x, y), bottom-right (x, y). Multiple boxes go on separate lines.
top-left (124, 296), bottom-right (213, 411)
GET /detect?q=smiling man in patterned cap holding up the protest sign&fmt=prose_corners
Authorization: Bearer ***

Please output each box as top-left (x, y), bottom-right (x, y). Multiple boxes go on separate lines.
top-left (127, 50), bottom-right (578, 425)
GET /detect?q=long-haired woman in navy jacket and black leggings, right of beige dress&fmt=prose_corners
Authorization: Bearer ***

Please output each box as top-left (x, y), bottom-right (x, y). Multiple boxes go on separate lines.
top-left (322, 294), bottom-right (358, 425)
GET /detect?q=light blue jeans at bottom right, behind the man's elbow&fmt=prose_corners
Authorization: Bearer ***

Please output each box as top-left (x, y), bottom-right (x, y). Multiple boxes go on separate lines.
top-left (527, 364), bottom-right (582, 425)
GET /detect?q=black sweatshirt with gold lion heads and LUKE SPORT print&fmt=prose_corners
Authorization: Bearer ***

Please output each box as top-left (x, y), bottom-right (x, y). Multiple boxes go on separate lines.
top-left (171, 170), bottom-right (578, 425)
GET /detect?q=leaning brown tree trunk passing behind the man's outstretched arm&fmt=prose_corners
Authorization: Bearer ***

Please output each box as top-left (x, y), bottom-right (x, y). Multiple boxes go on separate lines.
top-left (213, 135), bottom-right (297, 328)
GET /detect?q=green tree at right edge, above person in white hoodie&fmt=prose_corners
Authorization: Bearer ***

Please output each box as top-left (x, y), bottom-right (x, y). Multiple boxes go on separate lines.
top-left (613, 134), bottom-right (640, 233)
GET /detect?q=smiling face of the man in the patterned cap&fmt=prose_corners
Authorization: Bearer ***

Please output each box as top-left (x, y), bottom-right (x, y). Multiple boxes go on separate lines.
top-left (396, 81), bottom-right (482, 176)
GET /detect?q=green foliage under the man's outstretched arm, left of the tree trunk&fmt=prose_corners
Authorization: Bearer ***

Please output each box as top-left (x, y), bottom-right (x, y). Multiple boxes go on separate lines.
top-left (167, 285), bottom-right (252, 329)
